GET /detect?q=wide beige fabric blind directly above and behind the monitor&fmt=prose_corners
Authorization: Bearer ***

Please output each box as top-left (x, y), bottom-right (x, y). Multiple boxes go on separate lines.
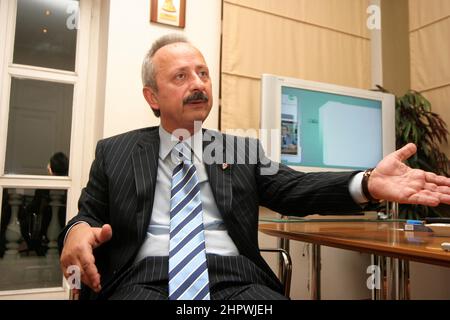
top-left (221, 0), bottom-right (371, 130)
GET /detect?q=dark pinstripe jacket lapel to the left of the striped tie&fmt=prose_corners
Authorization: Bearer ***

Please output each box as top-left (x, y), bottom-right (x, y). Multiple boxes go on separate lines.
top-left (132, 127), bottom-right (160, 239)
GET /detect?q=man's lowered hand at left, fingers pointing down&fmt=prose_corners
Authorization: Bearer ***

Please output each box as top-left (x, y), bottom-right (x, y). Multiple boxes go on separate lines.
top-left (60, 223), bottom-right (112, 292)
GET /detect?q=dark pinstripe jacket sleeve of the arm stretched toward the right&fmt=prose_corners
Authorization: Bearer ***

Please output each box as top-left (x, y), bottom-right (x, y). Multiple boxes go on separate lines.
top-left (255, 140), bottom-right (362, 216)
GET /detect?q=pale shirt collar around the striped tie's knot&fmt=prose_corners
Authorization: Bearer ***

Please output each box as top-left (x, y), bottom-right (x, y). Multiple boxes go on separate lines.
top-left (159, 125), bottom-right (203, 162)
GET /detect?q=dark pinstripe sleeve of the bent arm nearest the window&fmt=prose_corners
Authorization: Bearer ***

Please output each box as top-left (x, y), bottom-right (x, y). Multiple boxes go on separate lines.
top-left (58, 141), bottom-right (109, 250)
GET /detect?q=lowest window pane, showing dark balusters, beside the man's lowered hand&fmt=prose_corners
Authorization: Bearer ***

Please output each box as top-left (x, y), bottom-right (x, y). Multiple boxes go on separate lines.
top-left (0, 189), bottom-right (67, 291)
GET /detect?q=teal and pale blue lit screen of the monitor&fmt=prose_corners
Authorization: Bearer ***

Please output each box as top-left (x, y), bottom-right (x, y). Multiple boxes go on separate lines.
top-left (281, 87), bottom-right (383, 170)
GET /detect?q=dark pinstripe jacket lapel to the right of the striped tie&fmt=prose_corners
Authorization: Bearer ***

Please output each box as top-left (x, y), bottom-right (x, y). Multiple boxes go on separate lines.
top-left (203, 130), bottom-right (233, 220)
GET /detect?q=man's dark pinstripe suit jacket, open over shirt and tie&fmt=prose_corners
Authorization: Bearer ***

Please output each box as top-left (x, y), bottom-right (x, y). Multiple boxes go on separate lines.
top-left (59, 127), bottom-right (361, 298)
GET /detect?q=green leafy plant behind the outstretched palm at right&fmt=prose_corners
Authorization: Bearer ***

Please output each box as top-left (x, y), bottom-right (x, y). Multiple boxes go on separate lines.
top-left (377, 86), bottom-right (450, 219)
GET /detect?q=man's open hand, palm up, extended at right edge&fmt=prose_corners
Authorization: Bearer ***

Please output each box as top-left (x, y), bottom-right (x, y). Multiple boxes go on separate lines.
top-left (368, 143), bottom-right (450, 206)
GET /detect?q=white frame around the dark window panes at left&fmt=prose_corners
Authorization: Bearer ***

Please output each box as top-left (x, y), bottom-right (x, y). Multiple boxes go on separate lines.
top-left (0, 0), bottom-right (100, 297)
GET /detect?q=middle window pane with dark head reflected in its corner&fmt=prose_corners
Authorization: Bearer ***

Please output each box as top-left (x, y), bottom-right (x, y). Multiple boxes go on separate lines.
top-left (5, 78), bottom-right (73, 176)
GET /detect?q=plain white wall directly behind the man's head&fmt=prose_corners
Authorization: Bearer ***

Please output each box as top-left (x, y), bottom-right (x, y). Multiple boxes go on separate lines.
top-left (103, 0), bottom-right (221, 137)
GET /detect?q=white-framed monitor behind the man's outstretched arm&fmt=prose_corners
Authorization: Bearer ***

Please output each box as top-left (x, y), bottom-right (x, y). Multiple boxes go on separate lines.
top-left (261, 74), bottom-right (395, 172)
